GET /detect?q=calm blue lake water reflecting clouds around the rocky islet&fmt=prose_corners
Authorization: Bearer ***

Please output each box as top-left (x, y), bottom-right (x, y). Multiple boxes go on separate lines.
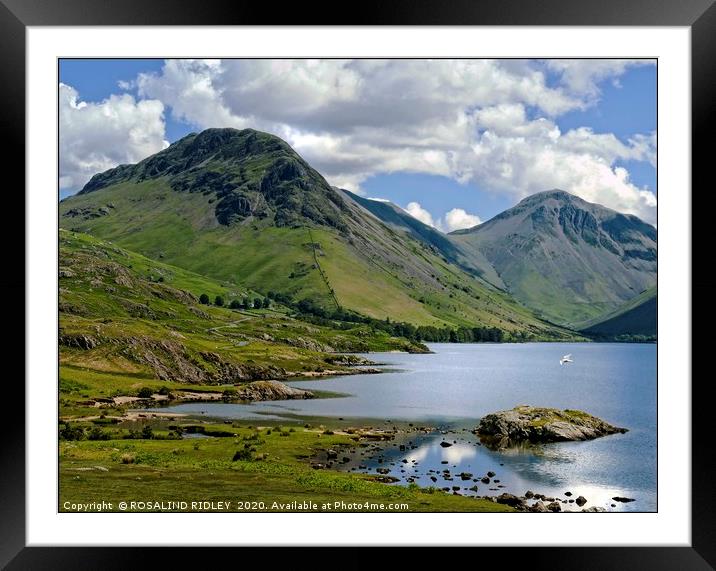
top-left (145, 343), bottom-right (656, 511)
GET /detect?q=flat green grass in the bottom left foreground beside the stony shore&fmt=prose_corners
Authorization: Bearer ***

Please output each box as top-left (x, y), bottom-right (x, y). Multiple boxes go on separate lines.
top-left (59, 425), bottom-right (512, 512)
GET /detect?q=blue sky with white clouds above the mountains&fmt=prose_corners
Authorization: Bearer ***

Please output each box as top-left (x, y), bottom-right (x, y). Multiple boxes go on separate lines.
top-left (59, 59), bottom-right (657, 228)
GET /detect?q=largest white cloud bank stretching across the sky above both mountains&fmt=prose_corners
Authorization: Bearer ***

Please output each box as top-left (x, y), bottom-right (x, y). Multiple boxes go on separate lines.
top-left (68, 60), bottom-right (656, 222)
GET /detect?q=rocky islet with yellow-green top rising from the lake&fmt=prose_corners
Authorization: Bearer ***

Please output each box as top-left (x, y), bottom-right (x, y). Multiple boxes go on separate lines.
top-left (475, 406), bottom-right (627, 447)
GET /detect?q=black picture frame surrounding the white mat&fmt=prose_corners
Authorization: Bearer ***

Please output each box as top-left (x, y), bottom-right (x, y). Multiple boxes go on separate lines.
top-left (0, 0), bottom-right (716, 570)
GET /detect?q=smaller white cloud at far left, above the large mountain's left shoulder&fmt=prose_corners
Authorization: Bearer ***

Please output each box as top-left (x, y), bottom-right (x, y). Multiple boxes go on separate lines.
top-left (59, 83), bottom-right (169, 190)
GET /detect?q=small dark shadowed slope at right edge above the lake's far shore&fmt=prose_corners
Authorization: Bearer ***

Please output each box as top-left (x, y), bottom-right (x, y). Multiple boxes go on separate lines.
top-left (578, 286), bottom-right (657, 339)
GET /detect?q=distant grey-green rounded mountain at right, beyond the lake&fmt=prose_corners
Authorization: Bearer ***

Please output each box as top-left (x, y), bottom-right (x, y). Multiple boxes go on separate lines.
top-left (450, 190), bottom-right (657, 326)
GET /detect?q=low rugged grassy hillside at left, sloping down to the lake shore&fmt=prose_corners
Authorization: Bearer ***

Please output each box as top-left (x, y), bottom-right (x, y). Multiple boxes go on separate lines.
top-left (59, 230), bottom-right (430, 413)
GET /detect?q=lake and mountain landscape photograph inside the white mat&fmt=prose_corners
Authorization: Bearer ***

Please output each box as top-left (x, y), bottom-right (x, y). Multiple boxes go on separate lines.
top-left (55, 59), bottom-right (656, 517)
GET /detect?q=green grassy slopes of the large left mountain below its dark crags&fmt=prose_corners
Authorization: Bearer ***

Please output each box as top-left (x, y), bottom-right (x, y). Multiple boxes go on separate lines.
top-left (60, 178), bottom-right (575, 340)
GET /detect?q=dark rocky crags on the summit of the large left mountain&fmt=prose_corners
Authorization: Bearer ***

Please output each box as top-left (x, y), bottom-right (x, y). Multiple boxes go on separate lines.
top-left (79, 128), bottom-right (345, 230)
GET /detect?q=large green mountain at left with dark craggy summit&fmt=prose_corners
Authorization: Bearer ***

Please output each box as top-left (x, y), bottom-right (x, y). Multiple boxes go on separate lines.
top-left (60, 129), bottom-right (573, 338)
